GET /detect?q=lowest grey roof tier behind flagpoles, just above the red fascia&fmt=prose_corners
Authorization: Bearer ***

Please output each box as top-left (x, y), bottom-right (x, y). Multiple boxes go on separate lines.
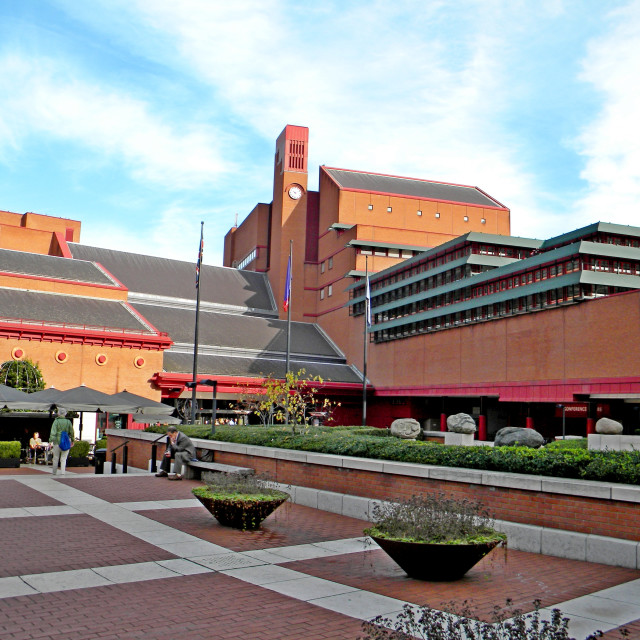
top-left (164, 350), bottom-right (362, 383)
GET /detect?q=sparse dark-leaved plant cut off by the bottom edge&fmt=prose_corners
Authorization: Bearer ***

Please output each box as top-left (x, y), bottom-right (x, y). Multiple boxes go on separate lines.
top-left (358, 599), bottom-right (629, 640)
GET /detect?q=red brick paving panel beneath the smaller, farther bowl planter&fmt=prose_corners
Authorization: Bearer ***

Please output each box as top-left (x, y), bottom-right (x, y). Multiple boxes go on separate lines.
top-left (140, 502), bottom-right (368, 551)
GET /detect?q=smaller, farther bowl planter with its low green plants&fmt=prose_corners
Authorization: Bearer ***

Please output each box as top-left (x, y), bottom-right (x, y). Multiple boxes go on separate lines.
top-left (191, 473), bottom-right (290, 530)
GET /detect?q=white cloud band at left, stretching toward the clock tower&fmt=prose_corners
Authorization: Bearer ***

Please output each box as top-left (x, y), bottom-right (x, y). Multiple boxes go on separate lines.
top-left (0, 54), bottom-right (230, 189)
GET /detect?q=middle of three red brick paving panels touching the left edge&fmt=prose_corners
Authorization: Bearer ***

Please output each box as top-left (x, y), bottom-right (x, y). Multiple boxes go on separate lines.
top-left (0, 514), bottom-right (175, 580)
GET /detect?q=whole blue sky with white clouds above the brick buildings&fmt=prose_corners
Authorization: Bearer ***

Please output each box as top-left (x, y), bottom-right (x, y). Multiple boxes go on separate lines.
top-left (0, 0), bottom-right (640, 264)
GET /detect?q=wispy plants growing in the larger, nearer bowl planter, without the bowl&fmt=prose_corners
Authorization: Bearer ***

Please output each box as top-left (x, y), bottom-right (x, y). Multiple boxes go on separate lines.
top-left (365, 492), bottom-right (506, 544)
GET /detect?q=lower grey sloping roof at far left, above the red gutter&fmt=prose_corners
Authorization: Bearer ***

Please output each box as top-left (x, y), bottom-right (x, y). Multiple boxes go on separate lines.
top-left (0, 288), bottom-right (155, 333)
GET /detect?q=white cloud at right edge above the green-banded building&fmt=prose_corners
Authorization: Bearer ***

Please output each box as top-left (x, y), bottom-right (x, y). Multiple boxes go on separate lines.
top-left (574, 0), bottom-right (640, 226)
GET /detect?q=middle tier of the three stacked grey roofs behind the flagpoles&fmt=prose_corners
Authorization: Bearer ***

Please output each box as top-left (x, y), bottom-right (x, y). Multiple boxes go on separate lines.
top-left (132, 303), bottom-right (344, 358)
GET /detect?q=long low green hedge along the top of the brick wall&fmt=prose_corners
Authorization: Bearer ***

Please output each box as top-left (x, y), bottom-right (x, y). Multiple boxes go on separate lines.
top-left (142, 425), bottom-right (640, 484)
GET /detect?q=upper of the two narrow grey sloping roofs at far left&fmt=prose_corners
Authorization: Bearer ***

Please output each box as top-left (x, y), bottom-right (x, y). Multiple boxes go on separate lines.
top-left (0, 249), bottom-right (115, 285)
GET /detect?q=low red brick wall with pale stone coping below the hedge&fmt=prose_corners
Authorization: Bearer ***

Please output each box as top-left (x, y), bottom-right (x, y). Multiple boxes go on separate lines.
top-left (107, 429), bottom-right (640, 549)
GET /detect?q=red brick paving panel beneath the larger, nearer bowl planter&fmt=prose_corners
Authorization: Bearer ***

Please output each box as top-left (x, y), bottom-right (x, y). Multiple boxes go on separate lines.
top-left (286, 549), bottom-right (640, 616)
